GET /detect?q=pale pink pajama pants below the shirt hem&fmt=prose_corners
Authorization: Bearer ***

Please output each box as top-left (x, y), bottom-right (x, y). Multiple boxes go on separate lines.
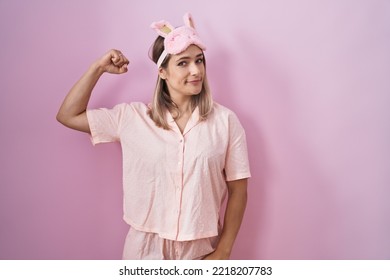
top-left (123, 228), bottom-right (219, 260)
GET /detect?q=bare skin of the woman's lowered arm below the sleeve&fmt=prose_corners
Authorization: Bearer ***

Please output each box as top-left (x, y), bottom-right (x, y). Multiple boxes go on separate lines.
top-left (204, 179), bottom-right (248, 260)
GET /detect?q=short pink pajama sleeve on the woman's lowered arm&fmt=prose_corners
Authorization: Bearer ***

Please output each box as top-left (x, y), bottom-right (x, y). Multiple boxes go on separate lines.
top-left (225, 113), bottom-right (251, 181)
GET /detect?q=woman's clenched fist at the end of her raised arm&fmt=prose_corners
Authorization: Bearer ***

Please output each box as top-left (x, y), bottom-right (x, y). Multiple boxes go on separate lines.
top-left (96, 49), bottom-right (129, 74)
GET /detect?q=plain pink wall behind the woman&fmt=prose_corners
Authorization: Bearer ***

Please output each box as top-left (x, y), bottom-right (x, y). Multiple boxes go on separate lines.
top-left (0, 0), bottom-right (390, 259)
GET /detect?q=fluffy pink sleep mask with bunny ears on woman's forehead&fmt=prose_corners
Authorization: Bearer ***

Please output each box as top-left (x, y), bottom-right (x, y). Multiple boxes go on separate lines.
top-left (150, 13), bottom-right (206, 68)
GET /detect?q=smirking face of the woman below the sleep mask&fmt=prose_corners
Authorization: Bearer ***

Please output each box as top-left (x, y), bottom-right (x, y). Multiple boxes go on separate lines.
top-left (159, 45), bottom-right (205, 100)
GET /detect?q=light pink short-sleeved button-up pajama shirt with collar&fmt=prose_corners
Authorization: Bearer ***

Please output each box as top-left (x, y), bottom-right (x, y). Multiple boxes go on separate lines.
top-left (87, 102), bottom-right (250, 256)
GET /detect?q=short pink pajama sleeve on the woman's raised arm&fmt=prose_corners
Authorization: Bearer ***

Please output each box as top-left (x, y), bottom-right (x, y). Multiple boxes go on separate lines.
top-left (87, 104), bottom-right (126, 145)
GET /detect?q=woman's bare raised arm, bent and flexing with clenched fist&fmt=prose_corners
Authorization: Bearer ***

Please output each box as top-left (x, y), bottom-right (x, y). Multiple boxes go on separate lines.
top-left (57, 50), bottom-right (129, 133)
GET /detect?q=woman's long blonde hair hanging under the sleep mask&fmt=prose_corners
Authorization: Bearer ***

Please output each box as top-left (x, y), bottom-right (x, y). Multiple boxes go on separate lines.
top-left (148, 36), bottom-right (213, 130)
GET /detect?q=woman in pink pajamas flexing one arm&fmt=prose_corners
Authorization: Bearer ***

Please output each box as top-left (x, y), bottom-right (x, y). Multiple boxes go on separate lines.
top-left (57, 14), bottom-right (250, 259)
